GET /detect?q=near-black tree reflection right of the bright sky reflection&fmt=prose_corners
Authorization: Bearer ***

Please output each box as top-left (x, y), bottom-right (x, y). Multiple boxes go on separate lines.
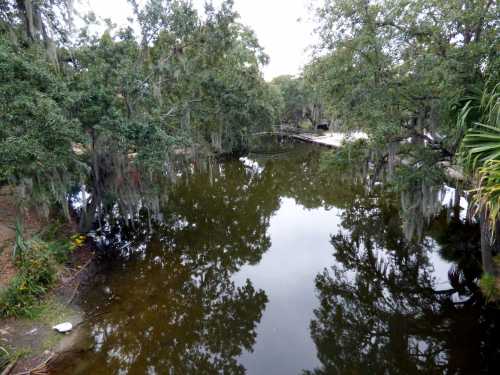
top-left (306, 192), bottom-right (500, 374)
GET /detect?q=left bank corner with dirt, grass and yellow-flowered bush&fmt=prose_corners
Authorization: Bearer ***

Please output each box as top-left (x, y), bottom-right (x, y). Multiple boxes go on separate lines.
top-left (0, 189), bottom-right (94, 374)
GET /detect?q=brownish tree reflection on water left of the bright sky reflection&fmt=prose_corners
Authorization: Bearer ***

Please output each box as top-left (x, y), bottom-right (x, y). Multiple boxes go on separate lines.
top-left (55, 158), bottom-right (279, 374)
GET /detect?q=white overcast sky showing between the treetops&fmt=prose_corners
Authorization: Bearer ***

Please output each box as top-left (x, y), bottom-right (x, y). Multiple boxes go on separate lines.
top-left (81, 0), bottom-right (314, 80)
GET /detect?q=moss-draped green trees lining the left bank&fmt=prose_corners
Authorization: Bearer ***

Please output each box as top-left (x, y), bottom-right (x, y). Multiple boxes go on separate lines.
top-left (0, 0), bottom-right (279, 222)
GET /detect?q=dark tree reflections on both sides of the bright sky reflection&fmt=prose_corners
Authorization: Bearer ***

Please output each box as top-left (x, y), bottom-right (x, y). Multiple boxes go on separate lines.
top-left (54, 142), bottom-right (500, 374)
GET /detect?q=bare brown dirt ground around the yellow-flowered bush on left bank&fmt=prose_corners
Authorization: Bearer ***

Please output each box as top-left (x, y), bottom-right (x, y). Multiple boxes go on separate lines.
top-left (0, 186), bottom-right (94, 374)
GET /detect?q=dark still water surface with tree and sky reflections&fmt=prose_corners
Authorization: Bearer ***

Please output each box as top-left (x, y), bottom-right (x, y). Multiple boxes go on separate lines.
top-left (51, 146), bottom-right (500, 374)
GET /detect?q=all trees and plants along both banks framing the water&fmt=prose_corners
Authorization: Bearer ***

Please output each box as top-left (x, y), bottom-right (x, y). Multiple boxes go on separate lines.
top-left (0, 0), bottom-right (500, 369)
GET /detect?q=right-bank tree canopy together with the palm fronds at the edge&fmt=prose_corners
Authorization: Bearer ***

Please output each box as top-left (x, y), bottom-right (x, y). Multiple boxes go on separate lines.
top-left (305, 0), bottom-right (500, 288)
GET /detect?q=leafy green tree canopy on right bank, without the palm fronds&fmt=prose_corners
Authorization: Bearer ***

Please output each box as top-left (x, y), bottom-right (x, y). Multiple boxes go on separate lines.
top-left (305, 0), bottom-right (500, 159)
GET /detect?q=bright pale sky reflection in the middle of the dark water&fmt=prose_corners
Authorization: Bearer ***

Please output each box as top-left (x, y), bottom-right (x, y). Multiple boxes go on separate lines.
top-left (234, 198), bottom-right (340, 375)
